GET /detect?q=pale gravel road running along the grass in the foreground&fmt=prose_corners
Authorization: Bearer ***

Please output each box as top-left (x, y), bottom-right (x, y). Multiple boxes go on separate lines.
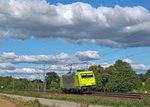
top-left (0, 93), bottom-right (106, 107)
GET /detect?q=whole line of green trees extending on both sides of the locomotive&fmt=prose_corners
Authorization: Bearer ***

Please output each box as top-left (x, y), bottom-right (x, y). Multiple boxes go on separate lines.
top-left (0, 60), bottom-right (150, 92)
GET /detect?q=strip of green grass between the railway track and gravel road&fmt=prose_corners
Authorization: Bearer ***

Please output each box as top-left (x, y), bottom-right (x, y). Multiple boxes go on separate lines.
top-left (0, 91), bottom-right (150, 107)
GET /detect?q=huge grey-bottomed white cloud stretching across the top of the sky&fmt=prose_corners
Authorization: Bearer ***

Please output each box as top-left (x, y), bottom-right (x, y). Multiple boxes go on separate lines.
top-left (0, 0), bottom-right (150, 47)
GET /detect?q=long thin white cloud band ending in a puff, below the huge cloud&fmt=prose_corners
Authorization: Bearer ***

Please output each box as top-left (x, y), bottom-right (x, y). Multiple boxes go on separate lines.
top-left (0, 51), bottom-right (99, 66)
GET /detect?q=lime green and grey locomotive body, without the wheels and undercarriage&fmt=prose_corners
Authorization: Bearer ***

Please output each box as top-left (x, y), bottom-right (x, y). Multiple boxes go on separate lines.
top-left (60, 71), bottom-right (96, 89)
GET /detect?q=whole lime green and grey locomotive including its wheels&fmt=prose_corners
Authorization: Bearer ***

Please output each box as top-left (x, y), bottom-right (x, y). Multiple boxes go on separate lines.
top-left (60, 70), bottom-right (96, 93)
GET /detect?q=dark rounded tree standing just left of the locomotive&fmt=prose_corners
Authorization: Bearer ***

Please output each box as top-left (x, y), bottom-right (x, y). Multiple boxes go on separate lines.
top-left (45, 72), bottom-right (60, 89)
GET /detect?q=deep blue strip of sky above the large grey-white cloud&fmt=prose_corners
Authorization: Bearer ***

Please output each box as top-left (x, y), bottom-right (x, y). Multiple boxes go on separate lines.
top-left (47, 0), bottom-right (150, 9)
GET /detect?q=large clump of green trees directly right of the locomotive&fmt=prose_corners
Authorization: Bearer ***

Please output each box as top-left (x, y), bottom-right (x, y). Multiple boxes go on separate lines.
top-left (89, 60), bottom-right (142, 92)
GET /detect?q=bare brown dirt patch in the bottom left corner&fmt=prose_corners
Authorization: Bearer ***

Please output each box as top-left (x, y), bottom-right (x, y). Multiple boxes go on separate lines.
top-left (0, 98), bottom-right (18, 107)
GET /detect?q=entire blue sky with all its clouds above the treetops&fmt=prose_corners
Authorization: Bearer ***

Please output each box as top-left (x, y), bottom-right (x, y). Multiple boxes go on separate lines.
top-left (0, 0), bottom-right (150, 79)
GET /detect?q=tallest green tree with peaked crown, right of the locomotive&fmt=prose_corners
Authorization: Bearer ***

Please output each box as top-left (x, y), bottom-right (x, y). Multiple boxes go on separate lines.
top-left (114, 60), bottom-right (142, 92)
